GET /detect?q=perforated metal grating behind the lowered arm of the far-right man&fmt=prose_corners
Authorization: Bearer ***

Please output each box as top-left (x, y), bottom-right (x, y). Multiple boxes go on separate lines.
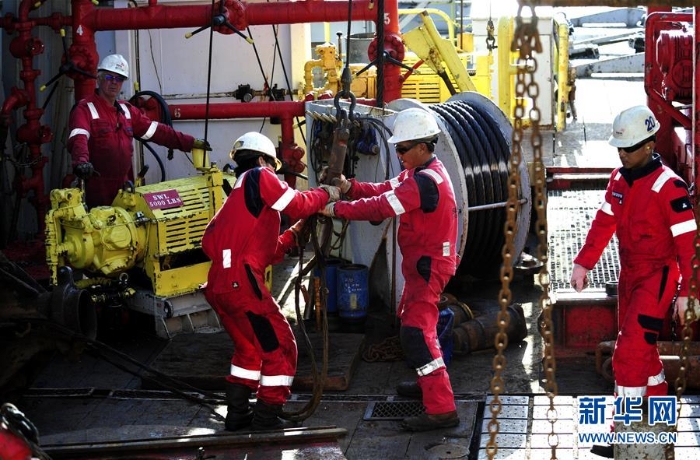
top-left (547, 189), bottom-right (620, 291)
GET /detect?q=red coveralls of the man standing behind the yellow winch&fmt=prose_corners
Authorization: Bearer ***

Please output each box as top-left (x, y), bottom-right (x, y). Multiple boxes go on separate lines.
top-left (67, 92), bottom-right (194, 207)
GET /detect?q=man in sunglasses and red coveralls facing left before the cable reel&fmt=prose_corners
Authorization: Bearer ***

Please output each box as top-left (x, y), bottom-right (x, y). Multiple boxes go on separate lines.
top-left (322, 108), bottom-right (459, 431)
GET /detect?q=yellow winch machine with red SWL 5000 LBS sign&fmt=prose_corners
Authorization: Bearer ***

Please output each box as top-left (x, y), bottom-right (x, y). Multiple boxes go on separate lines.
top-left (46, 155), bottom-right (233, 337)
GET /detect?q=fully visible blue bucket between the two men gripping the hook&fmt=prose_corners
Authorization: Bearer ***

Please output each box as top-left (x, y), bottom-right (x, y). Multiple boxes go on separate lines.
top-left (336, 264), bottom-right (369, 321)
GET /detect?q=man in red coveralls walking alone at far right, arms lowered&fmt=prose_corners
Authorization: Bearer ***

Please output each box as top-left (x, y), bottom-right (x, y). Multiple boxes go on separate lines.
top-left (571, 106), bottom-right (697, 458)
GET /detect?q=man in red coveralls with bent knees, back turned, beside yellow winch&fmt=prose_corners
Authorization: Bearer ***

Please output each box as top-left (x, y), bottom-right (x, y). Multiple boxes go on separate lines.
top-left (202, 132), bottom-right (340, 431)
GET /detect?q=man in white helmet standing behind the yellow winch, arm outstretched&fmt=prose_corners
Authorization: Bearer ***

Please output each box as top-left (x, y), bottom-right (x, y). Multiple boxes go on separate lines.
top-left (67, 54), bottom-right (209, 207)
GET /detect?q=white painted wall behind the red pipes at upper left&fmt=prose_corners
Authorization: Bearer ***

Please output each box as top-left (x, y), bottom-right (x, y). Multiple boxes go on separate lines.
top-left (108, 1), bottom-right (309, 183)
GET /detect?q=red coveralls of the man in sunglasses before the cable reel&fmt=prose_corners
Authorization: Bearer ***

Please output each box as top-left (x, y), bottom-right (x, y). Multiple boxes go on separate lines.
top-left (334, 157), bottom-right (457, 414)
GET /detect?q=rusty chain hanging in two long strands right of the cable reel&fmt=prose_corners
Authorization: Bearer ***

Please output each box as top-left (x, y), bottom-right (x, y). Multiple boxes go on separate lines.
top-left (486, 2), bottom-right (559, 460)
